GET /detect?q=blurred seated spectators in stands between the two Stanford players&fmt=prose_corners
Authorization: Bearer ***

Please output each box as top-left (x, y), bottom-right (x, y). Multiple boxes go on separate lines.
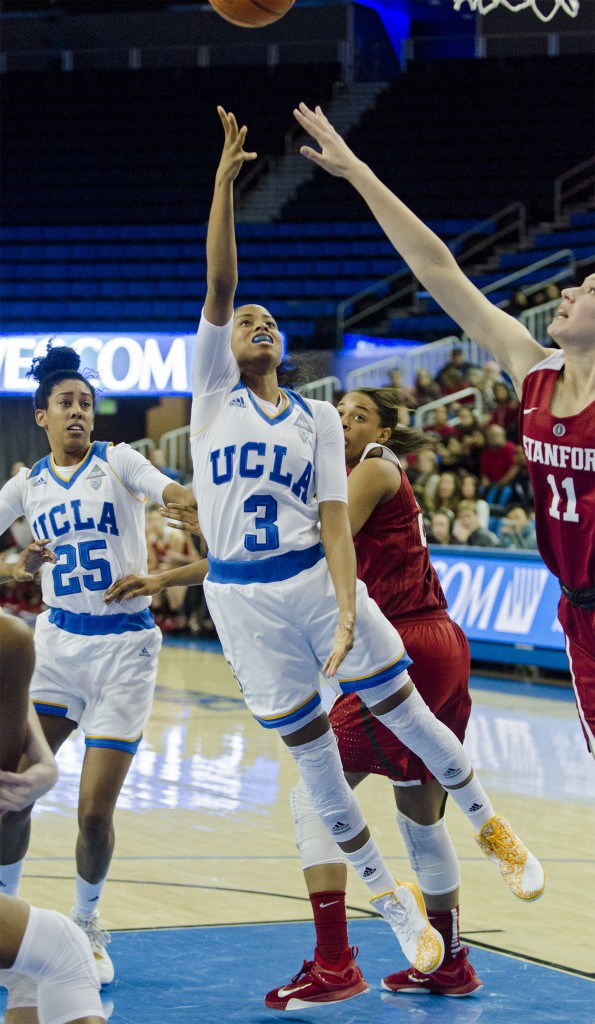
top-left (390, 346), bottom-right (537, 550)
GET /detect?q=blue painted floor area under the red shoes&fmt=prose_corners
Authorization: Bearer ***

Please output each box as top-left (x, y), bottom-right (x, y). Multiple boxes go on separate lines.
top-left (0, 921), bottom-right (595, 1024)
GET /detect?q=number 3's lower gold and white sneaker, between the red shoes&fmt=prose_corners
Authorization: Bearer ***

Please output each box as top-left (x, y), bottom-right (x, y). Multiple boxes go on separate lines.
top-left (370, 882), bottom-right (444, 974)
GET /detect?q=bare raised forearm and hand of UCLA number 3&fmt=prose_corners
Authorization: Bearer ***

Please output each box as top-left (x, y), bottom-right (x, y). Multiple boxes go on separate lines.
top-left (205, 106), bottom-right (257, 327)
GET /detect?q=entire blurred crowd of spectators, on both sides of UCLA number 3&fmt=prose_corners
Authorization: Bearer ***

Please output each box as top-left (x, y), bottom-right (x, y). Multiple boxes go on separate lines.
top-left (0, 335), bottom-right (537, 622)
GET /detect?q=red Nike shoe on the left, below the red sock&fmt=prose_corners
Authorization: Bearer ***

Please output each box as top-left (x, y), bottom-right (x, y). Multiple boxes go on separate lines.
top-left (264, 946), bottom-right (370, 1010)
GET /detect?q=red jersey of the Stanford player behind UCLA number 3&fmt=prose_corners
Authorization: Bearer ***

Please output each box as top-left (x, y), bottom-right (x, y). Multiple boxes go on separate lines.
top-left (348, 452), bottom-right (447, 623)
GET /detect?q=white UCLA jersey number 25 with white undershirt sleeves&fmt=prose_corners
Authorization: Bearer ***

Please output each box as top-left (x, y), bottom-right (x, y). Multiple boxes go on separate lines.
top-left (0, 441), bottom-right (171, 615)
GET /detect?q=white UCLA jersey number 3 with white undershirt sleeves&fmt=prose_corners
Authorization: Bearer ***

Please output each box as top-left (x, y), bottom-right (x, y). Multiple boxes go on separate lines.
top-left (190, 317), bottom-right (347, 561)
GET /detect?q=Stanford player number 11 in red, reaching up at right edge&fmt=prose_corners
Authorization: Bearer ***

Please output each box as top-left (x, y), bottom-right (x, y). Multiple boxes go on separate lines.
top-left (294, 103), bottom-right (595, 756)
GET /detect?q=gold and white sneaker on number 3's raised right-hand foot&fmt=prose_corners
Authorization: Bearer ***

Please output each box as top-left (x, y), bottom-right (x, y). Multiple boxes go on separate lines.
top-left (475, 814), bottom-right (546, 902)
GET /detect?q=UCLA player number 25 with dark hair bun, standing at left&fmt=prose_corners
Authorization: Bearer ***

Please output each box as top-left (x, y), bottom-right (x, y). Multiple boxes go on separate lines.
top-left (0, 345), bottom-right (192, 984)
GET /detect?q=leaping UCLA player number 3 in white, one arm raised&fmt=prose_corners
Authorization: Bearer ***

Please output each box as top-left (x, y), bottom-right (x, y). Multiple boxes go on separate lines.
top-left (182, 108), bottom-right (545, 991)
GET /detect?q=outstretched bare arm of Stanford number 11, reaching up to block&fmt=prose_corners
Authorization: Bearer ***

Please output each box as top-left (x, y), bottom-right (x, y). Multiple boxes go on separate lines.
top-left (294, 103), bottom-right (546, 394)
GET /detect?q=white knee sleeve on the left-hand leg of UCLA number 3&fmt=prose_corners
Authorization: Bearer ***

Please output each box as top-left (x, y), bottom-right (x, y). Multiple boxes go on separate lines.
top-left (288, 730), bottom-right (366, 843)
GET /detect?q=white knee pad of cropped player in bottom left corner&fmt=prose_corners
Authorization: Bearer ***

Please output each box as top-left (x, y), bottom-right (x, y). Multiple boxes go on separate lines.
top-left (13, 906), bottom-right (104, 1024)
